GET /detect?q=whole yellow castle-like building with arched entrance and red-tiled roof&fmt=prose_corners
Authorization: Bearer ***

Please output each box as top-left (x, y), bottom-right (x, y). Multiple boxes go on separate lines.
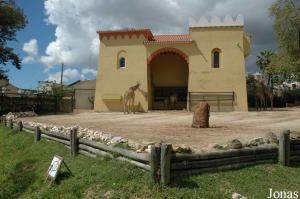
top-left (94, 15), bottom-right (250, 111)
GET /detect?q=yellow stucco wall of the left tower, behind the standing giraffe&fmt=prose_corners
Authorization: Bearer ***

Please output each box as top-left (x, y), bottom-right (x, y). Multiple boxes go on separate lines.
top-left (95, 35), bottom-right (148, 111)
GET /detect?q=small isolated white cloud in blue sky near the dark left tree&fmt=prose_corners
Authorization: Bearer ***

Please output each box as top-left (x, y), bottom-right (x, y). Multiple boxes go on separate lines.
top-left (22, 39), bottom-right (39, 64)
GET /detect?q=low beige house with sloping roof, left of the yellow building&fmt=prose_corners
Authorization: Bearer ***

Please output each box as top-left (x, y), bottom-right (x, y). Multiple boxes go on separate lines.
top-left (68, 80), bottom-right (96, 109)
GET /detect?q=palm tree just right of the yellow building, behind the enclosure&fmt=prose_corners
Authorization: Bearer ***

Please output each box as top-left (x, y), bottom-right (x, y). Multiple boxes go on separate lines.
top-left (256, 50), bottom-right (274, 88)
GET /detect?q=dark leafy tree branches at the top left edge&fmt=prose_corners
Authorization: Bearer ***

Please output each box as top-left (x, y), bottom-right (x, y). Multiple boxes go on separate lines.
top-left (0, 0), bottom-right (27, 79)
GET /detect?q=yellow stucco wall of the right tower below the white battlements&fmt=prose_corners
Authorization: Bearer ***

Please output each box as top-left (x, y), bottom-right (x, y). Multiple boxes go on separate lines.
top-left (189, 27), bottom-right (248, 111)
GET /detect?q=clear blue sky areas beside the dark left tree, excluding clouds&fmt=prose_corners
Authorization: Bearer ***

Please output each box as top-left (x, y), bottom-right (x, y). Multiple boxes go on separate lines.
top-left (8, 0), bottom-right (55, 88)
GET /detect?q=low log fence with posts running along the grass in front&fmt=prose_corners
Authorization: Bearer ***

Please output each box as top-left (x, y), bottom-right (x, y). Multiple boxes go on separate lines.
top-left (0, 117), bottom-right (300, 185)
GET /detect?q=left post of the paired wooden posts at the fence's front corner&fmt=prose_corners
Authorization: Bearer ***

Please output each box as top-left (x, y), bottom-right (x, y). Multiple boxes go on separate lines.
top-left (150, 145), bottom-right (160, 183)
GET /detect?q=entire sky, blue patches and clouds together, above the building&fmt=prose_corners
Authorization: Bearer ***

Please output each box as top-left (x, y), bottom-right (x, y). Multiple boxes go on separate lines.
top-left (7, 0), bottom-right (276, 89)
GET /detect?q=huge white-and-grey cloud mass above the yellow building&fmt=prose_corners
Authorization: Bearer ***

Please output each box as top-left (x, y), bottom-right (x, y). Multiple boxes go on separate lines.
top-left (28, 0), bottom-right (275, 73)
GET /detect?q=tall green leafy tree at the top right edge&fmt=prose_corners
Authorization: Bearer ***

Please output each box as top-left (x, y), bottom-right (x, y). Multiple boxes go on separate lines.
top-left (270, 0), bottom-right (300, 80)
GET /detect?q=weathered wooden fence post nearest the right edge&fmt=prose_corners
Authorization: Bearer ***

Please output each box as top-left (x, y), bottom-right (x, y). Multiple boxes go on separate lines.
top-left (278, 130), bottom-right (291, 166)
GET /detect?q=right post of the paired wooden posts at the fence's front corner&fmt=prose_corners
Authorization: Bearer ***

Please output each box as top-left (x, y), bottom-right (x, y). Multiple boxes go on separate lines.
top-left (160, 144), bottom-right (172, 185)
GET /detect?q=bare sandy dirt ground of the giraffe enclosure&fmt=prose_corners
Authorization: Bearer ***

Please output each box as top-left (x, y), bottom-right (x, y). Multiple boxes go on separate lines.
top-left (24, 107), bottom-right (300, 150)
